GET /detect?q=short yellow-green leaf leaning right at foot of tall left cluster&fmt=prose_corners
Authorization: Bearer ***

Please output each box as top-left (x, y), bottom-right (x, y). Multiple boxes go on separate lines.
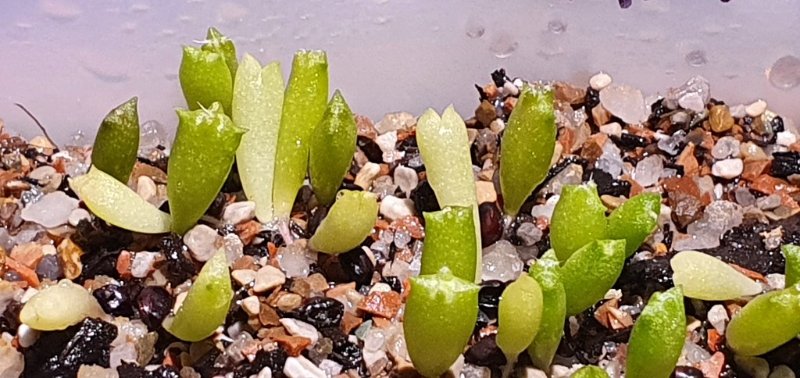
top-left (309, 190), bottom-right (378, 254)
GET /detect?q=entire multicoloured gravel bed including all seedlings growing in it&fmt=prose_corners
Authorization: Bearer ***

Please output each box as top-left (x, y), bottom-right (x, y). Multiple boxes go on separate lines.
top-left (0, 26), bottom-right (800, 378)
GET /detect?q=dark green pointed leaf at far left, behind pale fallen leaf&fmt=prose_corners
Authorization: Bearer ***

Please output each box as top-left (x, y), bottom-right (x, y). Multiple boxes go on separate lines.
top-left (92, 97), bottom-right (139, 184)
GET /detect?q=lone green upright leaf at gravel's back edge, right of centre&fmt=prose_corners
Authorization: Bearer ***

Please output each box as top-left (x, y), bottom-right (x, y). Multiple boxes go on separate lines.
top-left (500, 89), bottom-right (556, 216)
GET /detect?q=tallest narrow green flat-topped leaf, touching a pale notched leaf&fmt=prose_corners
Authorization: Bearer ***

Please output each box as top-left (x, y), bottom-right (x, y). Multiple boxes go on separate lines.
top-left (272, 51), bottom-right (328, 218)
